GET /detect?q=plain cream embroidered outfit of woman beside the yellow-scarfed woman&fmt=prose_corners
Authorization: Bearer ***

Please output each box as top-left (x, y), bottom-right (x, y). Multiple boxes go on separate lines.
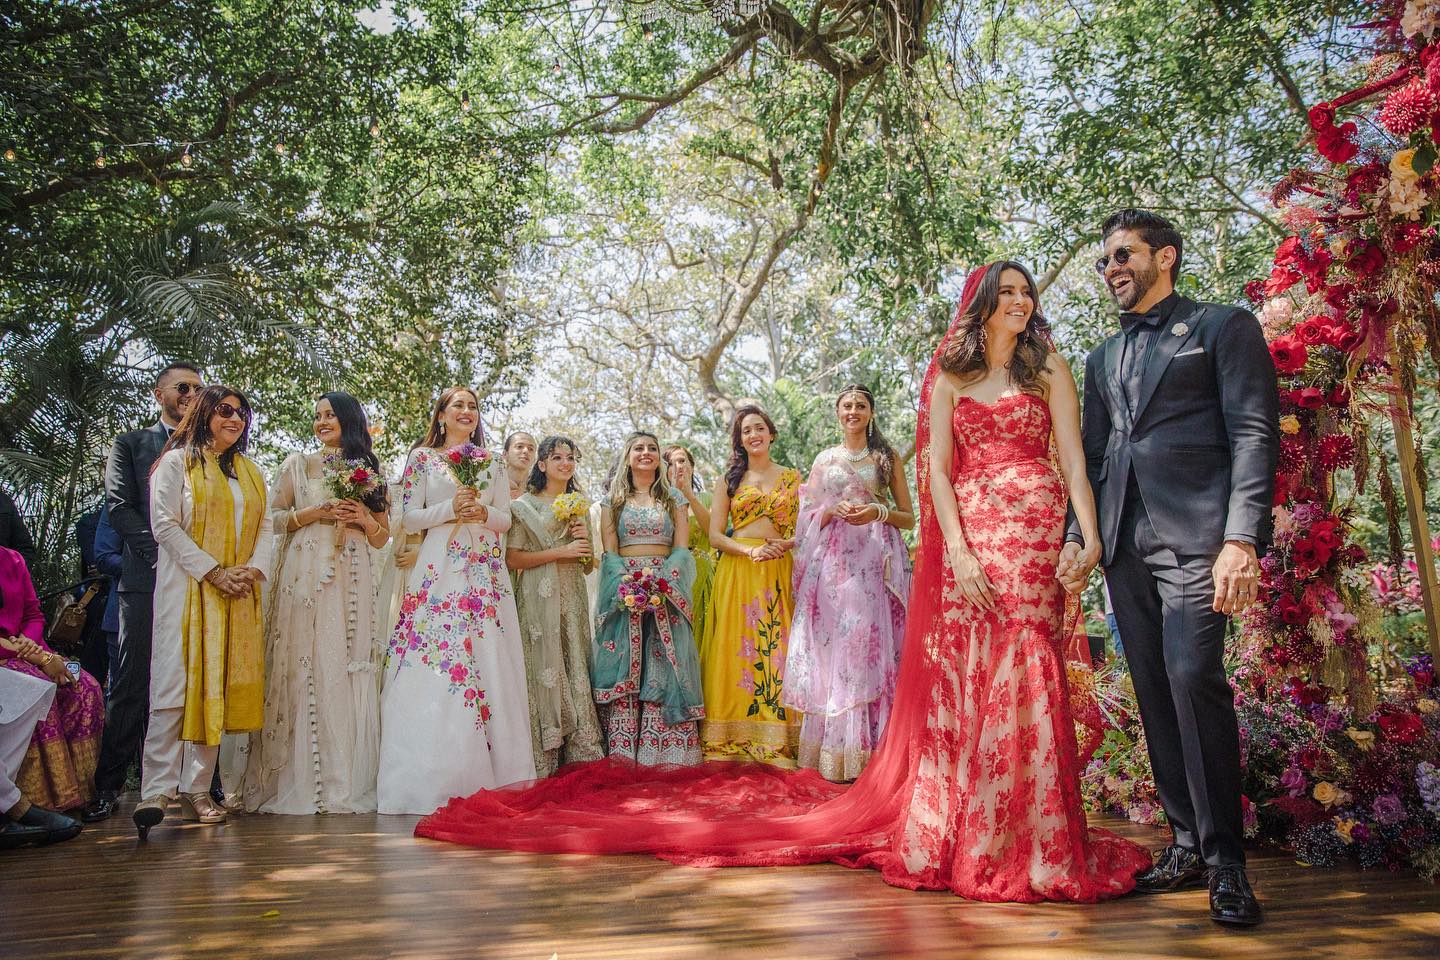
top-left (242, 453), bottom-right (382, 813)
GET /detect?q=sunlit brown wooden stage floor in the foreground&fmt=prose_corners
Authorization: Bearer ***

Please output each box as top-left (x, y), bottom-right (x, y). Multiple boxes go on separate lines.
top-left (8, 805), bottom-right (1440, 960)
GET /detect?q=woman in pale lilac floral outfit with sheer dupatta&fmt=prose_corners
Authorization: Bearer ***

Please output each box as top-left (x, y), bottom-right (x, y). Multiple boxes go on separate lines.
top-left (785, 384), bottom-right (914, 780)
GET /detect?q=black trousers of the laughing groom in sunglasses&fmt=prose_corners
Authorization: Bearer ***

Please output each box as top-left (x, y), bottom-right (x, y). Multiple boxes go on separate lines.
top-left (1104, 498), bottom-right (1246, 866)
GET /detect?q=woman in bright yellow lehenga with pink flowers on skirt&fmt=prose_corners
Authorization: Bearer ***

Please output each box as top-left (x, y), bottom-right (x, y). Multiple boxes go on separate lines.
top-left (700, 406), bottom-right (801, 767)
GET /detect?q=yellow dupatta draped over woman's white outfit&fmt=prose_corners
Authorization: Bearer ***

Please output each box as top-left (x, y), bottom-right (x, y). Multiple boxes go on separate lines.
top-left (180, 453), bottom-right (265, 746)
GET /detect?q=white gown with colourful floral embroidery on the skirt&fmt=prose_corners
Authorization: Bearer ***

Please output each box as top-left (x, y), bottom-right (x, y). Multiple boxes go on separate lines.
top-left (379, 448), bottom-right (536, 813)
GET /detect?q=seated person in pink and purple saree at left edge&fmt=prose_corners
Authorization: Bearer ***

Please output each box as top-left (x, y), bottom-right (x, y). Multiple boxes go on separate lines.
top-left (0, 547), bottom-right (105, 810)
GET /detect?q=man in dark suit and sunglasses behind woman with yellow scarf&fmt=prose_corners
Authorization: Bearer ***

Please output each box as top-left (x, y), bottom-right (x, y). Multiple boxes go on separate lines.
top-left (85, 363), bottom-right (204, 822)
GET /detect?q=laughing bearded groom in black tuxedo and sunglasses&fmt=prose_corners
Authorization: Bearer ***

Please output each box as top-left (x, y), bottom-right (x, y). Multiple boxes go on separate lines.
top-left (1060, 210), bottom-right (1280, 924)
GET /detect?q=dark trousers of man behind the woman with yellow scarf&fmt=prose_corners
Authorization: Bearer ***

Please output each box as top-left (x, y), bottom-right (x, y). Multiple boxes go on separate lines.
top-left (95, 590), bottom-right (154, 792)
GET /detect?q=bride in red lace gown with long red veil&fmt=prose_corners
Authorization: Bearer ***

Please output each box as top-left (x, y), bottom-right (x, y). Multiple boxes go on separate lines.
top-left (416, 262), bottom-right (1151, 902)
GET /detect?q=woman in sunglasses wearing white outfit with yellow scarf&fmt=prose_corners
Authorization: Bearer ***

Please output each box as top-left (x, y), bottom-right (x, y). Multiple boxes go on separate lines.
top-left (132, 386), bottom-right (272, 838)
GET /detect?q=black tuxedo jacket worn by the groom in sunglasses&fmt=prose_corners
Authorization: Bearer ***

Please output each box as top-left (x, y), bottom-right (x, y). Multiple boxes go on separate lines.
top-left (1066, 296), bottom-right (1280, 564)
